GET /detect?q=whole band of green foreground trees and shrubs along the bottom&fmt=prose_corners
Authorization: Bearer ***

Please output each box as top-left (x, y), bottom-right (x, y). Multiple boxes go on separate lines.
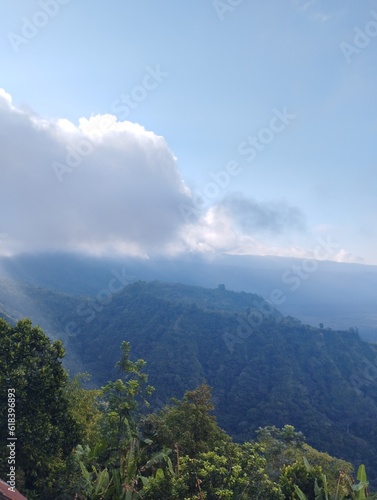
top-left (0, 320), bottom-right (374, 500)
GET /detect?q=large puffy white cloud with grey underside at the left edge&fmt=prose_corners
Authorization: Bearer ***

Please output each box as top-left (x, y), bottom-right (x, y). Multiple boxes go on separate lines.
top-left (0, 91), bottom-right (189, 254)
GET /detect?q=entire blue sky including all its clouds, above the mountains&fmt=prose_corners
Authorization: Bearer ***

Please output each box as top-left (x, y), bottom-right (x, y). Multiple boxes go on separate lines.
top-left (0, 0), bottom-right (377, 265)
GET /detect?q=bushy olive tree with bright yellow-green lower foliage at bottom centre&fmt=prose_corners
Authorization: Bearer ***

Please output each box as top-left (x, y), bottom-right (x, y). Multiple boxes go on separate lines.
top-left (140, 384), bottom-right (282, 500)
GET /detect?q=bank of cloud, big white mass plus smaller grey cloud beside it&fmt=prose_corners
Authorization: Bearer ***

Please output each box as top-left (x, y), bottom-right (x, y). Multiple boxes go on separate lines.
top-left (0, 89), bottom-right (344, 257)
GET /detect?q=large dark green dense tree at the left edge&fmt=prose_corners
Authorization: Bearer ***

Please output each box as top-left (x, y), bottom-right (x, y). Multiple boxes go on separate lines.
top-left (0, 319), bottom-right (80, 499)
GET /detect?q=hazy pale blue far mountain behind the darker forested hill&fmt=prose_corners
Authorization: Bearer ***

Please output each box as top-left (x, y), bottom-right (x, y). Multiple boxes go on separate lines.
top-left (0, 254), bottom-right (377, 341)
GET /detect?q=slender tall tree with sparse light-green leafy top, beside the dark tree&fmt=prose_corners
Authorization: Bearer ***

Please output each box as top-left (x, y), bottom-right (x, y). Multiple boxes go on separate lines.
top-left (72, 342), bottom-right (157, 500)
